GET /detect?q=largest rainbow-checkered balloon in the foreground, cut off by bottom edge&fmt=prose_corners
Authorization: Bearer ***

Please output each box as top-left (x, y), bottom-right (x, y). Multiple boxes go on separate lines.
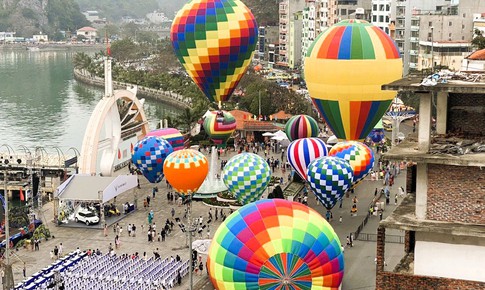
top-left (207, 199), bottom-right (344, 290)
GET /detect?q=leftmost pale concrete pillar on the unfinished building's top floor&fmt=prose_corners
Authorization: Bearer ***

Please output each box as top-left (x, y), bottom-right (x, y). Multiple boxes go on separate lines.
top-left (418, 92), bottom-right (432, 152)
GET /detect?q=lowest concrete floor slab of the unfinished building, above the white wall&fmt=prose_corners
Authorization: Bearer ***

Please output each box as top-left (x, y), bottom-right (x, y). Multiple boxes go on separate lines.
top-left (380, 194), bottom-right (485, 238)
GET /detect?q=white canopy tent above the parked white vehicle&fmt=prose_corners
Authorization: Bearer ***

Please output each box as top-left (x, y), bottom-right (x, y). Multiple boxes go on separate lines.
top-left (57, 174), bottom-right (138, 203)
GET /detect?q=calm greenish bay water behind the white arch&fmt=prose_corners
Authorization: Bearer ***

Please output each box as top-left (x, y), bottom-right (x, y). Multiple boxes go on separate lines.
top-left (0, 48), bottom-right (178, 152)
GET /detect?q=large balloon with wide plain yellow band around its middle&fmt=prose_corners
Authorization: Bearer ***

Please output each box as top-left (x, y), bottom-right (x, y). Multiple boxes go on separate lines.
top-left (305, 19), bottom-right (402, 140)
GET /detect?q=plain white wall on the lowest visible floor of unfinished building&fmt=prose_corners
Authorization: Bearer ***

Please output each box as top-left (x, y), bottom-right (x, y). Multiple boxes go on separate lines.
top-left (414, 232), bottom-right (485, 282)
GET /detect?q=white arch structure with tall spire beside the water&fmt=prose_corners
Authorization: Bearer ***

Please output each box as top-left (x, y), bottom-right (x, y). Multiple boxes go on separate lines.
top-left (79, 60), bottom-right (149, 176)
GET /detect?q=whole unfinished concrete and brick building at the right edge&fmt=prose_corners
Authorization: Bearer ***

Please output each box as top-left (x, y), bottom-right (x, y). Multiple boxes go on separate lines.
top-left (376, 78), bottom-right (485, 289)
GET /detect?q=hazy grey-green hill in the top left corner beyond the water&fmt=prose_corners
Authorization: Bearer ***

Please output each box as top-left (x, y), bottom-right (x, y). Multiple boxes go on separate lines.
top-left (0, 0), bottom-right (89, 39)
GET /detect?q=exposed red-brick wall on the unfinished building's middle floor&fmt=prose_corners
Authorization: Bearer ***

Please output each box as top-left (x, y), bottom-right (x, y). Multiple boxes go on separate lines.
top-left (427, 164), bottom-right (485, 224)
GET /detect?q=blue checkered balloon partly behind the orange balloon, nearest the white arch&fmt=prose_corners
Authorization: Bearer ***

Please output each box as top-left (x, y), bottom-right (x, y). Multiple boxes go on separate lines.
top-left (131, 136), bottom-right (173, 183)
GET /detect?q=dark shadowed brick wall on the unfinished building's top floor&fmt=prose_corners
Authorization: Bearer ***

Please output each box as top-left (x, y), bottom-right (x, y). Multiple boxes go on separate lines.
top-left (446, 94), bottom-right (485, 136)
